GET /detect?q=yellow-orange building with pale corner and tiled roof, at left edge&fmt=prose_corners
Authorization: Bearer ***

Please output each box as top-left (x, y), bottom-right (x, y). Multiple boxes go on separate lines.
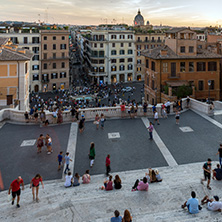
top-left (0, 38), bottom-right (33, 110)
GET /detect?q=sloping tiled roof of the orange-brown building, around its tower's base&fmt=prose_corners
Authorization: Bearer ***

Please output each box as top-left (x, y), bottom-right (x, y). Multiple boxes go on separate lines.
top-left (142, 45), bottom-right (222, 59)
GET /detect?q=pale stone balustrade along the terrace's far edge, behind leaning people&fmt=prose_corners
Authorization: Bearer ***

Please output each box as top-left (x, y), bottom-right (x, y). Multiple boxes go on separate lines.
top-left (0, 98), bottom-right (215, 123)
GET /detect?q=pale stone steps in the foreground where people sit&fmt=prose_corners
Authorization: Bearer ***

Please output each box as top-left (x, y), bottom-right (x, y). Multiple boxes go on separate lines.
top-left (0, 163), bottom-right (222, 222)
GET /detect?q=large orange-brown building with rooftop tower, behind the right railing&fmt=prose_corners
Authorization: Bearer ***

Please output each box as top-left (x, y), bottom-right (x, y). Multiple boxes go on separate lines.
top-left (143, 28), bottom-right (222, 104)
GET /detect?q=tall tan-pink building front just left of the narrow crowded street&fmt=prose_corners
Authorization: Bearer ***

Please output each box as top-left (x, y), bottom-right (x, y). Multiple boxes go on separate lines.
top-left (40, 30), bottom-right (69, 92)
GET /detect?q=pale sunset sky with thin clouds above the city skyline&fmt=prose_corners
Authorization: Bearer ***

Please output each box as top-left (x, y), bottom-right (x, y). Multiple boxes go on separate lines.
top-left (0, 0), bottom-right (222, 27)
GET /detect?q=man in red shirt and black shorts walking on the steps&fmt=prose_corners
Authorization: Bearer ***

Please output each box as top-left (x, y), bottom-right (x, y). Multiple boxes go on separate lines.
top-left (8, 176), bottom-right (24, 207)
